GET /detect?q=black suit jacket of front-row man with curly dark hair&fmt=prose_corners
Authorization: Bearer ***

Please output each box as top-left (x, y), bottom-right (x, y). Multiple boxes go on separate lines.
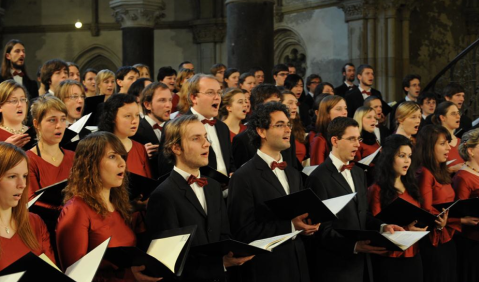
top-left (228, 154), bottom-right (309, 282)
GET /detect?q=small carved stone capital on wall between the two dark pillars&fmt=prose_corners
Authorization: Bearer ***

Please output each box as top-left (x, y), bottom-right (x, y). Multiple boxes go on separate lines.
top-left (191, 18), bottom-right (226, 44)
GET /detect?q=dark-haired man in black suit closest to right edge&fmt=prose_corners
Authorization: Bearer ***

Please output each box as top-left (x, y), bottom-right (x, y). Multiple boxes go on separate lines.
top-left (442, 82), bottom-right (472, 138)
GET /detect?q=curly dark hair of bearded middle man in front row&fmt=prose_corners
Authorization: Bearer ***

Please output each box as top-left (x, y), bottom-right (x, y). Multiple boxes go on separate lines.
top-left (246, 102), bottom-right (289, 149)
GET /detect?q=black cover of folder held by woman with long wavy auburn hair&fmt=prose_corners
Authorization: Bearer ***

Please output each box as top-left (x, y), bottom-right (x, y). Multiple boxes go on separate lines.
top-left (105, 225), bottom-right (197, 277)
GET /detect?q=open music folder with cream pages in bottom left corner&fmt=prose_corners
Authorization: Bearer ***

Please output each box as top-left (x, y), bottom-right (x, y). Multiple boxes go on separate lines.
top-left (0, 237), bottom-right (111, 282)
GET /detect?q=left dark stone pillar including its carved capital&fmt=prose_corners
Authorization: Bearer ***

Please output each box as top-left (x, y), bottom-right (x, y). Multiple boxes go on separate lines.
top-left (110, 0), bottom-right (165, 74)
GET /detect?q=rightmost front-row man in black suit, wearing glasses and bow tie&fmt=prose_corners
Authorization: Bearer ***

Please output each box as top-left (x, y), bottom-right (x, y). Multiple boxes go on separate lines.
top-left (306, 117), bottom-right (404, 282)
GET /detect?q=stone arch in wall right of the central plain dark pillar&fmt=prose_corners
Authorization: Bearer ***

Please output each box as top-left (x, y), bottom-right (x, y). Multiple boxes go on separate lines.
top-left (274, 28), bottom-right (307, 77)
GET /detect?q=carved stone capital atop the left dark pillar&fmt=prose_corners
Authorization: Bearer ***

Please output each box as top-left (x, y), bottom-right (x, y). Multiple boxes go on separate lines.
top-left (110, 0), bottom-right (165, 28)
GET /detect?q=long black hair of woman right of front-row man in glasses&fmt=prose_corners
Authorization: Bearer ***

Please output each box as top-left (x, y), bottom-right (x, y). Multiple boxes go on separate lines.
top-left (374, 134), bottom-right (422, 208)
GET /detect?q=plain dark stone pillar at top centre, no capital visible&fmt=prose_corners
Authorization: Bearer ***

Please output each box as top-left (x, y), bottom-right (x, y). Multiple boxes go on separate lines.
top-left (225, 0), bottom-right (274, 83)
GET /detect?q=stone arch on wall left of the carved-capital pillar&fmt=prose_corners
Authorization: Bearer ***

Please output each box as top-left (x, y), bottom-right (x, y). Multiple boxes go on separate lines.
top-left (73, 45), bottom-right (122, 73)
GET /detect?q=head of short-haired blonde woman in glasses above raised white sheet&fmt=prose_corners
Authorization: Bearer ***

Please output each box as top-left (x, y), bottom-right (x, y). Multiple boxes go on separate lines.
top-left (55, 79), bottom-right (86, 126)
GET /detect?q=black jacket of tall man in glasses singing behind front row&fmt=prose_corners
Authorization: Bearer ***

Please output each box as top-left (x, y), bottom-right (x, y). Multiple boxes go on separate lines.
top-left (186, 109), bottom-right (236, 174)
